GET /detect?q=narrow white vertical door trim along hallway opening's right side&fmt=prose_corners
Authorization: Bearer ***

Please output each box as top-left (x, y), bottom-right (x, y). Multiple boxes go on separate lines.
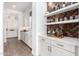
top-left (32, 2), bottom-right (36, 55)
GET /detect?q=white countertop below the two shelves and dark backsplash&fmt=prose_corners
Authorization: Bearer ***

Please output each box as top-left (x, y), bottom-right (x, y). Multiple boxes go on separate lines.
top-left (39, 35), bottom-right (79, 46)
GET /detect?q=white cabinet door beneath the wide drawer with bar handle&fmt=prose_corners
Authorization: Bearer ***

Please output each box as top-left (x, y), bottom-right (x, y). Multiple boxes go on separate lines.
top-left (51, 46), bottom-right (74, 56)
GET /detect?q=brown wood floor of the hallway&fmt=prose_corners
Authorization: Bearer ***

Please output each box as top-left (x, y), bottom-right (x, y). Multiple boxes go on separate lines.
top-left (4, 38), bottom-right (32, 56)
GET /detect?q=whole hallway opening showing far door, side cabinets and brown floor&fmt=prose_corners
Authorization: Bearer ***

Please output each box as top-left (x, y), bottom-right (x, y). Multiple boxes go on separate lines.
top-left (3, 2), bottom-right (32, 56)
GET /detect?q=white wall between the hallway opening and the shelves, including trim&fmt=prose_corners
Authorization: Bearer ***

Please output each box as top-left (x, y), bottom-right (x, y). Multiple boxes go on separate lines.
top-left (32, 2), bottom-right (47, 55)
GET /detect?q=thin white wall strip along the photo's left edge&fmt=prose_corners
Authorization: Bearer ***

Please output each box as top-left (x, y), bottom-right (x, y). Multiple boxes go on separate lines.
top-left (0, 2), bottom-right (3, 56)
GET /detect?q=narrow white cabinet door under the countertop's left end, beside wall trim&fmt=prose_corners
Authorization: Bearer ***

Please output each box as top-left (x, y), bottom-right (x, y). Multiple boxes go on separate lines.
top-left (39, 38), bottom-right (50, 56)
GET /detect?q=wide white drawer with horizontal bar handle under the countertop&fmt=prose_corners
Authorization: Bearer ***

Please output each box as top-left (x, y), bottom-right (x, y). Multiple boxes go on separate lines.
top-left (51, 41), bottom-right (75, 53)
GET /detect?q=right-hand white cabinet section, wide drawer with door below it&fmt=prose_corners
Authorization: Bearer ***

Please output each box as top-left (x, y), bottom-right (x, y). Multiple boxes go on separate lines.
top-left (51, 41), bottom-right (75, 56)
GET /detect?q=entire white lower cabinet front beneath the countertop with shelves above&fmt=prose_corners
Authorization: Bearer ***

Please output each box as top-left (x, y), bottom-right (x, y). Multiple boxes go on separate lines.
top-left (39, 37), bottom-right (75, 56)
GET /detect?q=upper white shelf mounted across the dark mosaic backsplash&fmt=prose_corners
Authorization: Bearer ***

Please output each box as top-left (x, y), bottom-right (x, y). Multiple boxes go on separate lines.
top-left (45, 3), bottom-right (79, 17)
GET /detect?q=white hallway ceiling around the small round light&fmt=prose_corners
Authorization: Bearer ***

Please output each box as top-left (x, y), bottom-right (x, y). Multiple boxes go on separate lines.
top-left (4, 2), bottom-right (32, 11)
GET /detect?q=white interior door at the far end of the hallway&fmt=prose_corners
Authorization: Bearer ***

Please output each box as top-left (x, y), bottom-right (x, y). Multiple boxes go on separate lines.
top-left (6, 14), bottom-right (18, 38)
